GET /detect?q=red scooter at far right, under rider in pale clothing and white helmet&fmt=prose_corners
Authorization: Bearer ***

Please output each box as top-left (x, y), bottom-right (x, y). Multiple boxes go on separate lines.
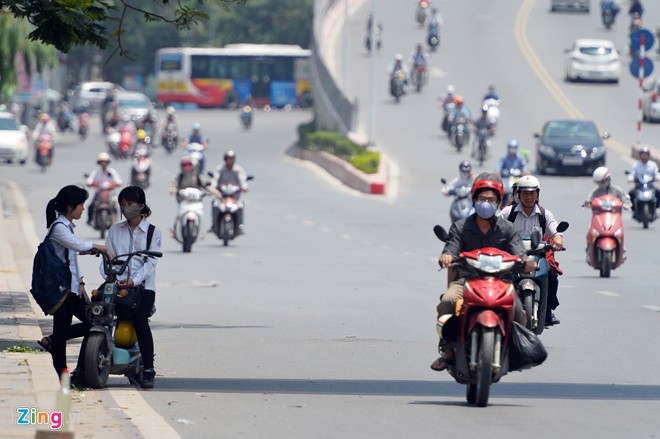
top-left (583, 195), bottom-right (626, 277)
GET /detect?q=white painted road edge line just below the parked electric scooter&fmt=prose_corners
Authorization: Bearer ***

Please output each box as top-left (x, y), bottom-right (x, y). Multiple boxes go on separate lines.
top-left (110, 388), bottom-right (181, 439)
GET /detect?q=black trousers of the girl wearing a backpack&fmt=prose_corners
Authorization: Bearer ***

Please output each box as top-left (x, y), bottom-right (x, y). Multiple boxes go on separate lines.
top-left (50, 293), bottom-right (91, 376)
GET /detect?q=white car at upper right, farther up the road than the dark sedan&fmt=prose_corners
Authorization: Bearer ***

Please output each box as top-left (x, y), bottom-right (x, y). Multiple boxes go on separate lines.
top-left (565, 38), bottom-right (621, 84)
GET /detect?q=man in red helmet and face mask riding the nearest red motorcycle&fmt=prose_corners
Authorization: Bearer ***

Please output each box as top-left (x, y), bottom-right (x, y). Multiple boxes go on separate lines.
top-left (431, 172), bottom-right (535, 371)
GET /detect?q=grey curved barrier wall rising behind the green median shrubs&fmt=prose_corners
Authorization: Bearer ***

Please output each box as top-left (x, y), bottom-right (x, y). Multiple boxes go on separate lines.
top-left (310, 0), bottom-right (357, 135)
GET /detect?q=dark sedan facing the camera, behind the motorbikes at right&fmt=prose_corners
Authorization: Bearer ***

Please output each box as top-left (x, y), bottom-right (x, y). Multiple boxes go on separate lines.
top-left (534, 119), bottom-right (609, 175)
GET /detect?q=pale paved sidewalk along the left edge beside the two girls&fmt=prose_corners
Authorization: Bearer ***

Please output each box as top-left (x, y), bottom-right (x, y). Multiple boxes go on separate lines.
top-left (0, 180), bottom-right (135, 439)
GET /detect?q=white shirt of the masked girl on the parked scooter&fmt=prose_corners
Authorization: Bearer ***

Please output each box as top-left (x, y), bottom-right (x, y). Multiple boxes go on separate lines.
top-left (100, 218), bottom-right (161, 291)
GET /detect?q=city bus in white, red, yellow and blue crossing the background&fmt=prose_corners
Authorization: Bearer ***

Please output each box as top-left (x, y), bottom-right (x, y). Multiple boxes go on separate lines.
top-left (156, 44), bottom-right (312, 108)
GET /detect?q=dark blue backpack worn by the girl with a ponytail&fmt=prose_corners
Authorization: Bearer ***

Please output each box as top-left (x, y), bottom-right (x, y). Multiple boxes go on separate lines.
top-left (30, 222), bottom-right (71, 315)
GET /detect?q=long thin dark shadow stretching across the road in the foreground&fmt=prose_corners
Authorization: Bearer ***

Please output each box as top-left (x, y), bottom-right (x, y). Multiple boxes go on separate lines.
top-left (148, 377), bottom-right (660, 400)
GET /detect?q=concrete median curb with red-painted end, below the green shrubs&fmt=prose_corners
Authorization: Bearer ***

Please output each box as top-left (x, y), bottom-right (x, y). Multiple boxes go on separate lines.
top-left (287, 145), bottom-right (389, 195)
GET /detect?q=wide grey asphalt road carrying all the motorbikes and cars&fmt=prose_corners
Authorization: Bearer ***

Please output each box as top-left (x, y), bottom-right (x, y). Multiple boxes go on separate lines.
top-left (5, 0), bottom-right (660, 438)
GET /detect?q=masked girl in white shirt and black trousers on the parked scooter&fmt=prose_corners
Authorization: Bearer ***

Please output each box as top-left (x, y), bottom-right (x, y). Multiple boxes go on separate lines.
top-left (101, 186), bottom-right (161, 389)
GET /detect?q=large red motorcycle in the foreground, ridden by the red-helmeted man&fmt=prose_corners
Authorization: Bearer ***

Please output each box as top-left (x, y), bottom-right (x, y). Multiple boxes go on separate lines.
top-left (433, 226), bottom-right (538, 407)
